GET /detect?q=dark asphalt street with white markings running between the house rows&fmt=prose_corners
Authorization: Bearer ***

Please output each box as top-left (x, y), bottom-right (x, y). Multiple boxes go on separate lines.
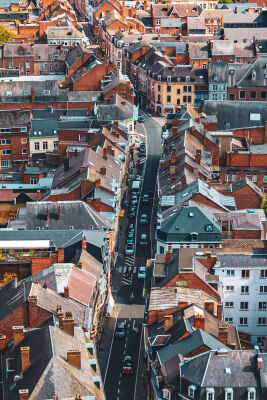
top-left (104, 117), bottom-right (161, 400)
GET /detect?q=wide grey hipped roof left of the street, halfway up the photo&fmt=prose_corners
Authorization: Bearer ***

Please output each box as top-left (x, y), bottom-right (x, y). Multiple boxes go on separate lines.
top-left (27, 201), bottom-right (113, 230)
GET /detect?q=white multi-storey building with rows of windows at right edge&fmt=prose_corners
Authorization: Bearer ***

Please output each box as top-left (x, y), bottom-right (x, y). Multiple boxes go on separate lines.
top-left (214, 254), bottom-right (267, 344)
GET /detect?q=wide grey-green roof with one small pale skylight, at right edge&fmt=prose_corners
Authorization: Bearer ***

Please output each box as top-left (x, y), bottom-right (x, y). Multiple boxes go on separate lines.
top-left (203, 100), bottom-right (267, 131)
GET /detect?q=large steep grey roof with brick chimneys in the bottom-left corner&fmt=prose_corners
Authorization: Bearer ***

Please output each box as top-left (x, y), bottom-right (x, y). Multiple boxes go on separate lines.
top-left (2, 326), bottom-right (102, 400)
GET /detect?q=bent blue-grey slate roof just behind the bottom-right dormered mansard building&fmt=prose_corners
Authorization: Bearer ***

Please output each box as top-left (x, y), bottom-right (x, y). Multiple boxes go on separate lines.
top-left (157, 329), bottom-right (230, 364)
